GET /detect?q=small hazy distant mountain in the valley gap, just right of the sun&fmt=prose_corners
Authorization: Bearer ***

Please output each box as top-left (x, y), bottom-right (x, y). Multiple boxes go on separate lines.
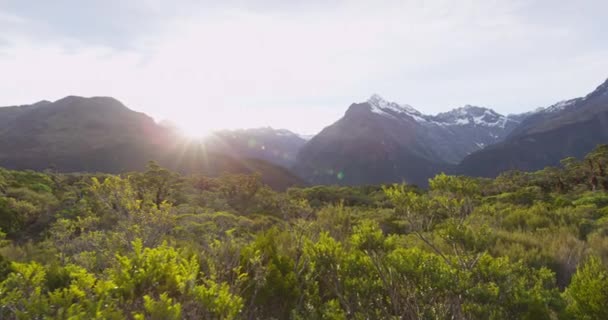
top-left (204, 128), bottom-right (306, 168)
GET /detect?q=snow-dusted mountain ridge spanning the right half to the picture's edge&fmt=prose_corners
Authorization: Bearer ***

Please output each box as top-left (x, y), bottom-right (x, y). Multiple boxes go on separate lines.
top-left (294, 80), bottom-right (608, 185)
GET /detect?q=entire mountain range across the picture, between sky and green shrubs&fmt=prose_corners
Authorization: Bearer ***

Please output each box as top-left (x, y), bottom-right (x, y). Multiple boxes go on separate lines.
top-left (0, 81), bottom-right (608, 189)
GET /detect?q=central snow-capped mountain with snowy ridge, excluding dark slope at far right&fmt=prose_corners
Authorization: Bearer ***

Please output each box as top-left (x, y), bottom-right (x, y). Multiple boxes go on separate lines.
top-left (294, 95), bottom-right (521, 184)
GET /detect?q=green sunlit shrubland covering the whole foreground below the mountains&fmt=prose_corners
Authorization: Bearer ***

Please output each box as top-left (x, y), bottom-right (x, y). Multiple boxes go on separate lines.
top-left (0, 146), bottom-right (608, 319)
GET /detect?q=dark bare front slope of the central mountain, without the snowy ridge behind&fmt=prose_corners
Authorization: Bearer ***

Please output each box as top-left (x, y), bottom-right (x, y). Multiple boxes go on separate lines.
top-left (296, 103), bottom-right (445, 185)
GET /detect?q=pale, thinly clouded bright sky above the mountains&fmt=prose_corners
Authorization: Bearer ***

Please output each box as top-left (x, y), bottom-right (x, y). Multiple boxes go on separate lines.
top-left (0, 0), bottom-right (608, 134)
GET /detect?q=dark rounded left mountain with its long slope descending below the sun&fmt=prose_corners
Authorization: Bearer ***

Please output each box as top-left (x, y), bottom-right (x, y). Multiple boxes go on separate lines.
top-left (0, 96), bottom-right (304, 188)
